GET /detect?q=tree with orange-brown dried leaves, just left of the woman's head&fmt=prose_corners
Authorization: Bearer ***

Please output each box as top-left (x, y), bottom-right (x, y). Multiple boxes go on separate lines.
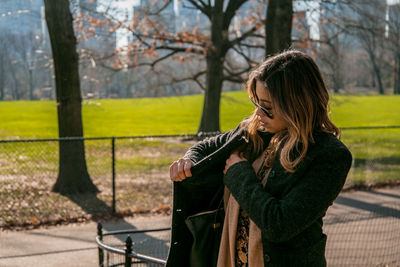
top-left (128, 0), bottom-right (263, 133)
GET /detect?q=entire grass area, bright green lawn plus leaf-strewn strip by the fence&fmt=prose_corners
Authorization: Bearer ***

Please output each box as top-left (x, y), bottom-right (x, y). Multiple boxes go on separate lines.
top-left (0, 92), bottom-right (400, 228)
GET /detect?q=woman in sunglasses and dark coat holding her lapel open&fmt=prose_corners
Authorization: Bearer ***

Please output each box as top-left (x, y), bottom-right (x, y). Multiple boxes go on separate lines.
top-left (167, 50), bottom-right (352, 267)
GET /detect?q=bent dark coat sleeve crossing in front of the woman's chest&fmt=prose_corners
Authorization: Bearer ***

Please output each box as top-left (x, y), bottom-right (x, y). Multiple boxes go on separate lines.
top-left (224, 147), bottom-right (352, 242)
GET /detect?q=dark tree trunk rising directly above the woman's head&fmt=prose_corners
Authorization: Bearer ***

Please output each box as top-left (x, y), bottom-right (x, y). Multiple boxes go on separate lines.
top-left (265, 0), bottom-right (293, 57)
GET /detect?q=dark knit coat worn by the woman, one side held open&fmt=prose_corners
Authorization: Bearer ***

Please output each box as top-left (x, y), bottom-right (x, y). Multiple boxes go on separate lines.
top-left (167, 124), bottom-right (352, 267)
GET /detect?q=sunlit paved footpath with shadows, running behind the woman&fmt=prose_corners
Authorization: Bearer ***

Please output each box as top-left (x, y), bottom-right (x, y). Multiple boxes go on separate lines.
top-left (0, 187), bottom-right (400, 267)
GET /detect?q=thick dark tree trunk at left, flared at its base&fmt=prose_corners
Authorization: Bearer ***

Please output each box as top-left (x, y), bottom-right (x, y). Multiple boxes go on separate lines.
top-left (44, 0), bottom-right (98, 194)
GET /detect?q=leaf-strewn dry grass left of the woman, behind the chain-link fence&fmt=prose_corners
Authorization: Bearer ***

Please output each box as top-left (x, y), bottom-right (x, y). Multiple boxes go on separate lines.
top-left (0, 138), bottom-right (194, 229)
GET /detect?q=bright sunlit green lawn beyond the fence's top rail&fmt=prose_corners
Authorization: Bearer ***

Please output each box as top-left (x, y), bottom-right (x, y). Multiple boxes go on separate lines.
top-left (0, 92), bottom-right (400, 139)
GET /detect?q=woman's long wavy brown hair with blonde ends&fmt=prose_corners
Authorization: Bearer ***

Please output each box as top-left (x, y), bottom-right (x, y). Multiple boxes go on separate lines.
top-left (241, 50), bottom-right (340, 172)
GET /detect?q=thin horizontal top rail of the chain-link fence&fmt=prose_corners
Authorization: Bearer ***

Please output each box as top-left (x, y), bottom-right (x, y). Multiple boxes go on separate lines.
top-left (0, 125), bottom-right (400, 143)
